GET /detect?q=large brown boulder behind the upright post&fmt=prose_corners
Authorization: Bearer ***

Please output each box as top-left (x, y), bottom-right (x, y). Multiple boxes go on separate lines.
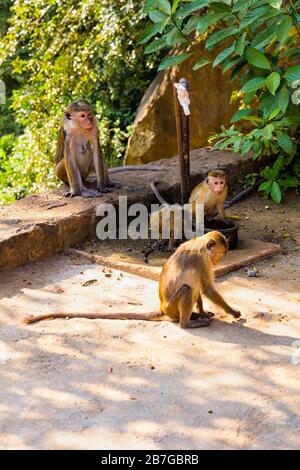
top-left (125, 56), bottom-right (238, 165)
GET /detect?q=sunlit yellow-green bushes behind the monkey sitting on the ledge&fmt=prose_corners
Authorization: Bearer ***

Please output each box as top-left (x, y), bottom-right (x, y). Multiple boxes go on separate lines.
top-left (0, 0), bottom-right (160, 204)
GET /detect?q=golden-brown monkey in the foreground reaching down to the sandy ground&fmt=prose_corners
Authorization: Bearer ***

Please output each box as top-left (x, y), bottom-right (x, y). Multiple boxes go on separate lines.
top-left (24, 231), bottom-right (241, 328)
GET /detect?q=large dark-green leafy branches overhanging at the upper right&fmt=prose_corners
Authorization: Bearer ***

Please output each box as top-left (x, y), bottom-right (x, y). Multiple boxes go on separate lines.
top-left (140, 0), bottom-right (300, 203)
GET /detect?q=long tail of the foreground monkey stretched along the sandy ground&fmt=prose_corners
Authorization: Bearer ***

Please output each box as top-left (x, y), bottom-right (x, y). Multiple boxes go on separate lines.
top-left (23, 312), bottom-right (169, 325)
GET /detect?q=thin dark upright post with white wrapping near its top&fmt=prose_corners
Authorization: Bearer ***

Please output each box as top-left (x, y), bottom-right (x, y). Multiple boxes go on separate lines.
top-left (172, 79), bottom-right (190, 205)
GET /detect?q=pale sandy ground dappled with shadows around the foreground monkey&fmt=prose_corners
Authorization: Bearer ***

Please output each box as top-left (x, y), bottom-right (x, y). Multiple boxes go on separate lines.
top-left (0, 194), bottom-right (300, 450)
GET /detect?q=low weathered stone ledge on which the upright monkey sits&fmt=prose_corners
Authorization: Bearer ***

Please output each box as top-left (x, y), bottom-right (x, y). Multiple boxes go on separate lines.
top-left (0, 148), bottom-right (258, 269)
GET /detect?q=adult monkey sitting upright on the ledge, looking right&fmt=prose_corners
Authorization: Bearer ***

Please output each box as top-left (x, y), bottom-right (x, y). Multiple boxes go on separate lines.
top-left (55, 100), bottom-right (159, 197)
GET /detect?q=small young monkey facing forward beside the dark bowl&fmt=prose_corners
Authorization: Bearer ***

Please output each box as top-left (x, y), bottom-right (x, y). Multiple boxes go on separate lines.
top-left (189, 170), bottom-right (228, 219)
